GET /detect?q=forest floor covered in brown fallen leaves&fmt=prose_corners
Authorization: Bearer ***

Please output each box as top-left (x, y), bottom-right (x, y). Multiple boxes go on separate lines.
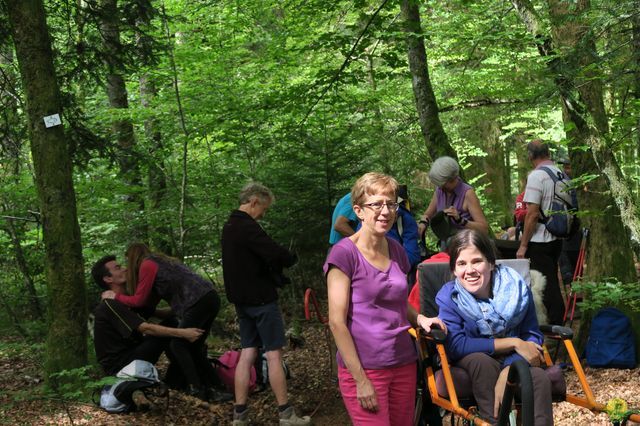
top-left (0, 323), bottom-right (640, 426)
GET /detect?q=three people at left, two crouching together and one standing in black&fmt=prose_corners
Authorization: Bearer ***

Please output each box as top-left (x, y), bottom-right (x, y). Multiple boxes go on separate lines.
top-left (91, 183), bottom-right (311, 425)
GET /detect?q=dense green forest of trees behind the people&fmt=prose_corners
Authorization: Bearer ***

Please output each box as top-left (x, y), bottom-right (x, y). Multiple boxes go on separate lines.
top-left (0, 0), bottom-right (640, 424)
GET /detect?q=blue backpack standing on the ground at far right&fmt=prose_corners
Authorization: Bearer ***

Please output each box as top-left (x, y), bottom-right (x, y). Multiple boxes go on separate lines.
top-left (585, 308), bottom-right (636, 368)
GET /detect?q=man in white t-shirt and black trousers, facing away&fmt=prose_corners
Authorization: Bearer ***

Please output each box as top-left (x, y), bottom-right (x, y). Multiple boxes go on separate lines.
top-left (516, 139), bottom-right (566, 324)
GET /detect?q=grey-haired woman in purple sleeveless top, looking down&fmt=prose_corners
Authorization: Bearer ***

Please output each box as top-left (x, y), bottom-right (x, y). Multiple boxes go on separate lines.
top-left (418, 157), bottom-right (489, 240)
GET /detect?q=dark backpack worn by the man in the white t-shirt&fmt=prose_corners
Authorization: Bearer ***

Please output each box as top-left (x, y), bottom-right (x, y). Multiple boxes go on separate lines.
top-left (538, 167), bottom-right (580, 238)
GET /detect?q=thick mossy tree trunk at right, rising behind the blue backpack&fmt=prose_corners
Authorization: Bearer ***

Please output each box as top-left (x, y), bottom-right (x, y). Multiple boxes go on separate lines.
top-left (549, 0), bottom-right (640, 282)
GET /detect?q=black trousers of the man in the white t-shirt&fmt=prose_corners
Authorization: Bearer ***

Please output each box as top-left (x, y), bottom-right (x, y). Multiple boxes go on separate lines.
top-left (526, 240), bottom-right (564, 325)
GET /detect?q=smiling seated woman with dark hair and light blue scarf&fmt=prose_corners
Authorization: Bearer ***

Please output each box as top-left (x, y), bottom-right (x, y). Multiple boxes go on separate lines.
top-left (436, 230), bottom-right (553, 426)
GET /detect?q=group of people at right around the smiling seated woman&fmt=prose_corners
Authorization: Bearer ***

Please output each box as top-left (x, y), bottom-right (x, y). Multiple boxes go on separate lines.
top-left (324, 140), bottom-right (564, 425)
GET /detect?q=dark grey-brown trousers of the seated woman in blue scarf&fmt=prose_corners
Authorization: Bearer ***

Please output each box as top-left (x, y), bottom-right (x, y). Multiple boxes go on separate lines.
top-left (456, 353), bottom-right (553, 426)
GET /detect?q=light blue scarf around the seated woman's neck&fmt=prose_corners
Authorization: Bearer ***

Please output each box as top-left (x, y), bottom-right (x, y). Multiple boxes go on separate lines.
top-left (452, 265), bottom-right (529, 337)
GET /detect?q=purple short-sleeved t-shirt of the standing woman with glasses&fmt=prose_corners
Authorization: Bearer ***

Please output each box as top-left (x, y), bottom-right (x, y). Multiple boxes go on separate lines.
top-left (323, 238), bottom-right (417, 369)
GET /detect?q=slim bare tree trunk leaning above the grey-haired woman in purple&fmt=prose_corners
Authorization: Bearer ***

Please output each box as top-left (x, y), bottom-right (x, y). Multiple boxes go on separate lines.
top-left (400, 0), bottom-right (462, 163)
